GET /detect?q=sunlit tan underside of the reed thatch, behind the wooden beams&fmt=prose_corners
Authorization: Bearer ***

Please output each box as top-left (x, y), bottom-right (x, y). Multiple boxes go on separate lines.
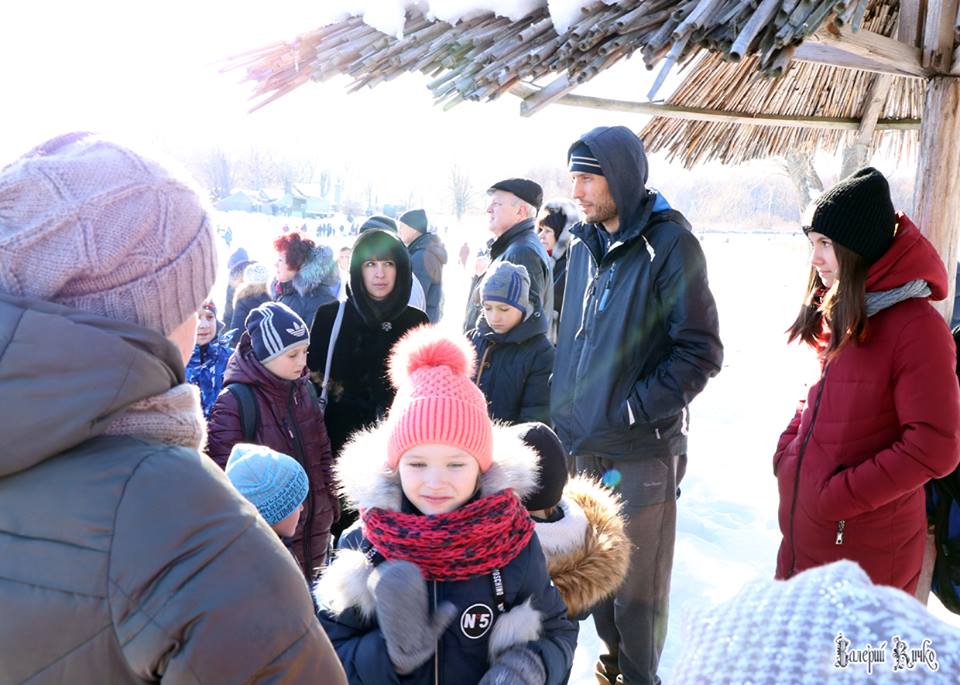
top-left (640, 5), bottom-right (923, 167)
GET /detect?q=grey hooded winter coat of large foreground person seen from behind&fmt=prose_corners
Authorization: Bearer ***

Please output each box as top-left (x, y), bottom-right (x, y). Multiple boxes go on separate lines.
top-left (0, 294), bottom-right (345, 685)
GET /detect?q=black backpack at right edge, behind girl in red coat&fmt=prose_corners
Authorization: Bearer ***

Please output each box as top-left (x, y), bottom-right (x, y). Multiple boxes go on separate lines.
top-left (926, 326), bottom-right (960, 614)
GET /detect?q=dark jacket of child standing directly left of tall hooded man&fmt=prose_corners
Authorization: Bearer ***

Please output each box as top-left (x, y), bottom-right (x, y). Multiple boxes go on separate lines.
top-left (467, 312), bottom-right (553, 423)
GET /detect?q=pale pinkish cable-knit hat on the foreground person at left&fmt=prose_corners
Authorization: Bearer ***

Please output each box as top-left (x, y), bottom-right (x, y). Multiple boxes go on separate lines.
top-left (0, 133), bottom-right (217, 335)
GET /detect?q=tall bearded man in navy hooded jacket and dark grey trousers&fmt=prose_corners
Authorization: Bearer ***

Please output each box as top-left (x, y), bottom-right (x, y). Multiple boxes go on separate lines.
top-left (550, 126), bottom-right (723, 685)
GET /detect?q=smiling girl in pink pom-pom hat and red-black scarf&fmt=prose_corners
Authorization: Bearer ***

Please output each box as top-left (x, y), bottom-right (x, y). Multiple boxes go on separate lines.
top-left (315, 327), bottom-right (577, 685)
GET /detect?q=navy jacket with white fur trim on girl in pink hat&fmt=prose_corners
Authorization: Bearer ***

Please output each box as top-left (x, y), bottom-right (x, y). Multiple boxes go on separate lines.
top-left (314, 424), bottom-right (577, 685)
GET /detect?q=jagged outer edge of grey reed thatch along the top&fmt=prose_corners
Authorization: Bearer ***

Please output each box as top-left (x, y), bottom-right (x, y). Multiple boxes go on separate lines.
top-left (228, 0), bottom-right (880, 106)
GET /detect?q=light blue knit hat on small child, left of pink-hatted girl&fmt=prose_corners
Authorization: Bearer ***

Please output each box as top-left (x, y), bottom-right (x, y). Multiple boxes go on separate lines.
top-left (227, 442), bottom-right (308, 526)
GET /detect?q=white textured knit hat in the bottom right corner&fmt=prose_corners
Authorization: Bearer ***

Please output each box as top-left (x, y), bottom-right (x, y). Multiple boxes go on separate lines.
top-left (670, 561), bottom-right (960, 685)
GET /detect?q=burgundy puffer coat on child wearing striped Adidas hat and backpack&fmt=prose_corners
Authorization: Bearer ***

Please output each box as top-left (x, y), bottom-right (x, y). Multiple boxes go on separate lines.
top-left (207, 333), bottom-right (337, 577)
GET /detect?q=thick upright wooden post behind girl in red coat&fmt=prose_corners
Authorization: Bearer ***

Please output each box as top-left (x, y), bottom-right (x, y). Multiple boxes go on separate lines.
top-left (911, 76), bottom-right (960, 321)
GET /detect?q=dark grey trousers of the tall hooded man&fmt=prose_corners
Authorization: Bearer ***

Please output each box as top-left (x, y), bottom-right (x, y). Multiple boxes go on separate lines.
top-left (577, 454), bottom-right (687, 685)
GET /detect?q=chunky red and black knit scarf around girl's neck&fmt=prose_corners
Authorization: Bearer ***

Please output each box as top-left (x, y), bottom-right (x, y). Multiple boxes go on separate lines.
top-left (360, 490), bottom-right (533, 581)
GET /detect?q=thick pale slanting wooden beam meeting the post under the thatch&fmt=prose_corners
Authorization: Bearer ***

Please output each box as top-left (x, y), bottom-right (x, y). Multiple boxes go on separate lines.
top-left (794, 25), bottom-right (929, 78)
